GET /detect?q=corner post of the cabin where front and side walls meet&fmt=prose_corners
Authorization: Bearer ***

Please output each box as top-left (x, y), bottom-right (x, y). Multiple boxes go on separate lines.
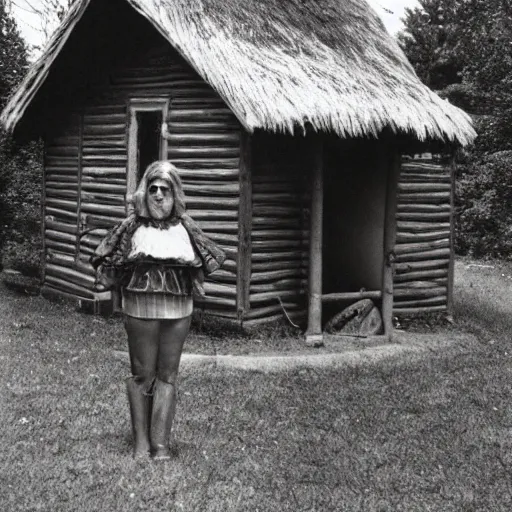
top-left (236, 128), bottom-right (252, 322)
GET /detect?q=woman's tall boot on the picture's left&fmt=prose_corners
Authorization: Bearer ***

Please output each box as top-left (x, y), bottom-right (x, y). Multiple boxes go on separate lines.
top-left (126, 377), bottom-right (151, 458)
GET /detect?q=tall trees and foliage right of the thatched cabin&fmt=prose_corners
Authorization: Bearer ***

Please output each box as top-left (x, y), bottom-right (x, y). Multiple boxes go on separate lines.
top-left (398, 0), bottom-right (512, 259)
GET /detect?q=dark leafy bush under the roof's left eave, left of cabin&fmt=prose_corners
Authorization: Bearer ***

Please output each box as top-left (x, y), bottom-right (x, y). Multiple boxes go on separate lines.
top-left (0, 136), bottom-right (43, 275)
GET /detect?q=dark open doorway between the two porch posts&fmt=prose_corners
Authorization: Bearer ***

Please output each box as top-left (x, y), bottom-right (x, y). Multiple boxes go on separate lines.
top-left (322, 139), bottom-right (387, 321)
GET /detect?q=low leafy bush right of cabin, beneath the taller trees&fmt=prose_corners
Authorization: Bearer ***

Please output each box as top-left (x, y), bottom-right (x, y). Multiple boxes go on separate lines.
top-left (456, 150), bottom-right (512, 258)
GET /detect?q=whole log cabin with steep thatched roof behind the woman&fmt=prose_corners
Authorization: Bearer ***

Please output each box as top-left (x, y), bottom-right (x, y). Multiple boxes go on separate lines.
top-left (0, 0), bottom-right (475, 343)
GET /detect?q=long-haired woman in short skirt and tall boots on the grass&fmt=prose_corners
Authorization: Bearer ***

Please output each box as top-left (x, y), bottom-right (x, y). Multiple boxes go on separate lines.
top-left (91, 161), bottom-right (225, 460)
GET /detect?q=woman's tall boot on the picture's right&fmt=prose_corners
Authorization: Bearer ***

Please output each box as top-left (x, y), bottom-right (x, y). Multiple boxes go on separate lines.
top-left (149, 379), bottom-right (176, 460)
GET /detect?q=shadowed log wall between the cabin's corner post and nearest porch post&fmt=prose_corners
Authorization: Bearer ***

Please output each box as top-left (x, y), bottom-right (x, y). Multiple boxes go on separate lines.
top-left (244, 135), bottom-right (310, 326)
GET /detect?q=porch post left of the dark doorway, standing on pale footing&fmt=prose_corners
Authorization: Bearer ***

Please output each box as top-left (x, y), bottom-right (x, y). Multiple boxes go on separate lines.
top-left (306, 136), bottom-right (324, 346)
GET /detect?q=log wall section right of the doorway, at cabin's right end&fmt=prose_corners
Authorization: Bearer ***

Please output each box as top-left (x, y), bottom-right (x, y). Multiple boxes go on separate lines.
top-left (393, 157), bottom-right (453, 315)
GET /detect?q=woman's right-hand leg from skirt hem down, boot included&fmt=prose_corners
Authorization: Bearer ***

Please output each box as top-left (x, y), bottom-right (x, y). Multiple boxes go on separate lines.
top-left (150, 317), bottom-right (191, 460)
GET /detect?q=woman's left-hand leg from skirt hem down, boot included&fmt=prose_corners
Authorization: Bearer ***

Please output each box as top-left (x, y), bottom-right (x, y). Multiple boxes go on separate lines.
top-left (125, 316), bottom-right (159, 458)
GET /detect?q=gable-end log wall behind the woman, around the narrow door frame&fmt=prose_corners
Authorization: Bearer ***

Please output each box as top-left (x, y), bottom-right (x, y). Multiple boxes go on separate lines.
top-left (45, 44), bottom-right (240, 318)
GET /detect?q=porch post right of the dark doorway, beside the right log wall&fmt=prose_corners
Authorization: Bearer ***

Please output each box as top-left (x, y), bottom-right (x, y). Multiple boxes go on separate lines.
top-left (381, 148), bottom-right (401, 341)
